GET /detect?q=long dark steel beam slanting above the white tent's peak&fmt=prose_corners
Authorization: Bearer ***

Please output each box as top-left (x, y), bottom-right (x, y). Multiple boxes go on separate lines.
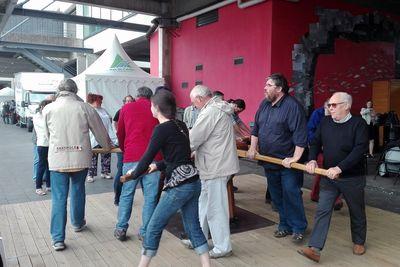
top-left (12, 8), bottom-right (150, 33)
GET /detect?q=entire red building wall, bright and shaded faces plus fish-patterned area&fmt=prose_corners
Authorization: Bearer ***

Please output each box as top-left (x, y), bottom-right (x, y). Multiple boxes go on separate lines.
top-left (151, 0), bottom-right (394, 123)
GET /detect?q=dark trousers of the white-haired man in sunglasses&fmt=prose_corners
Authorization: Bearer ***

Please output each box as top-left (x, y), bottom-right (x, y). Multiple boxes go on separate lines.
top-left (308, 176), bottom-right (367, 249)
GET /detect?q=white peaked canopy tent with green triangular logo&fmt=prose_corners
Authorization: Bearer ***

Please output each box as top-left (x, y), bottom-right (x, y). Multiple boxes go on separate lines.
top-left (73, 36), bottom-right (164, 115)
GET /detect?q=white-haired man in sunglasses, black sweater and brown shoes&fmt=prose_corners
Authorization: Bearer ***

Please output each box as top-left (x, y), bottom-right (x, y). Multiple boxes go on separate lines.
top-left (298, 92), bottom-right (368, 262)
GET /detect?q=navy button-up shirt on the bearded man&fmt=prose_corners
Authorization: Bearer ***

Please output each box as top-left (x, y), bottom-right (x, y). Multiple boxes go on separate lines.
top-left (251, 95), bottom-right (307, 169)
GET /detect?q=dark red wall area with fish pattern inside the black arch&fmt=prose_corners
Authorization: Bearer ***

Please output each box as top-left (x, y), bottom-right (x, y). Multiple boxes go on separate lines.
top-left (314, 40), bottom-right (394, 114)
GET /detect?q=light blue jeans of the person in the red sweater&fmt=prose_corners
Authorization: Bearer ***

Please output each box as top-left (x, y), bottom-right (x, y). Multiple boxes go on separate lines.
top-left (116, 162), bottom-right (160, 236)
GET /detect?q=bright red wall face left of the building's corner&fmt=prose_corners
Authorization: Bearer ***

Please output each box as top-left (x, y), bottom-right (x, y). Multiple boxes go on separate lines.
top-left (167, 1), bottom-right (272, 122)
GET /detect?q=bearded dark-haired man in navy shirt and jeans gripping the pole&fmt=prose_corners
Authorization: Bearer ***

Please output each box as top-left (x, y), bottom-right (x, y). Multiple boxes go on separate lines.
top-left (248, 73), bottom-right (307, 243)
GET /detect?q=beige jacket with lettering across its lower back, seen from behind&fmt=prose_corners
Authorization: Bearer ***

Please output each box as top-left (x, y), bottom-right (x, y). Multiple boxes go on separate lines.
top-left (43, 92), bottom-right (110, 170)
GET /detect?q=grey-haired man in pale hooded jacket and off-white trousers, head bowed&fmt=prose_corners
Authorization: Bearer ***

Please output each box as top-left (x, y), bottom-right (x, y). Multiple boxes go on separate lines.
top-left (190, 85), bottom-right (239, 258)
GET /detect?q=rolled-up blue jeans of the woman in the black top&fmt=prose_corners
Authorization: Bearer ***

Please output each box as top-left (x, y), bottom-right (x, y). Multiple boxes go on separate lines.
top-left (142, 180), bottom-right (208, 257)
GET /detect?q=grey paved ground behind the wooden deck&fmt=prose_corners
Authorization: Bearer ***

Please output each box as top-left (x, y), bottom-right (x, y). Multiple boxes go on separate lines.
top-left (0, 124), bottom-right (400, 213)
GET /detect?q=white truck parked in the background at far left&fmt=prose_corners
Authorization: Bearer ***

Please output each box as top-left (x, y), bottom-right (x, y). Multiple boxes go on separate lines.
top-left (14, 72), bottom-right (64, 132)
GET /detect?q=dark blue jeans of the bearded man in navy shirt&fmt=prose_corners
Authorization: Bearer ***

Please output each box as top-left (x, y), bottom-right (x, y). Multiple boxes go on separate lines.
top-left (265, 168), bottom-right (307, 234)
